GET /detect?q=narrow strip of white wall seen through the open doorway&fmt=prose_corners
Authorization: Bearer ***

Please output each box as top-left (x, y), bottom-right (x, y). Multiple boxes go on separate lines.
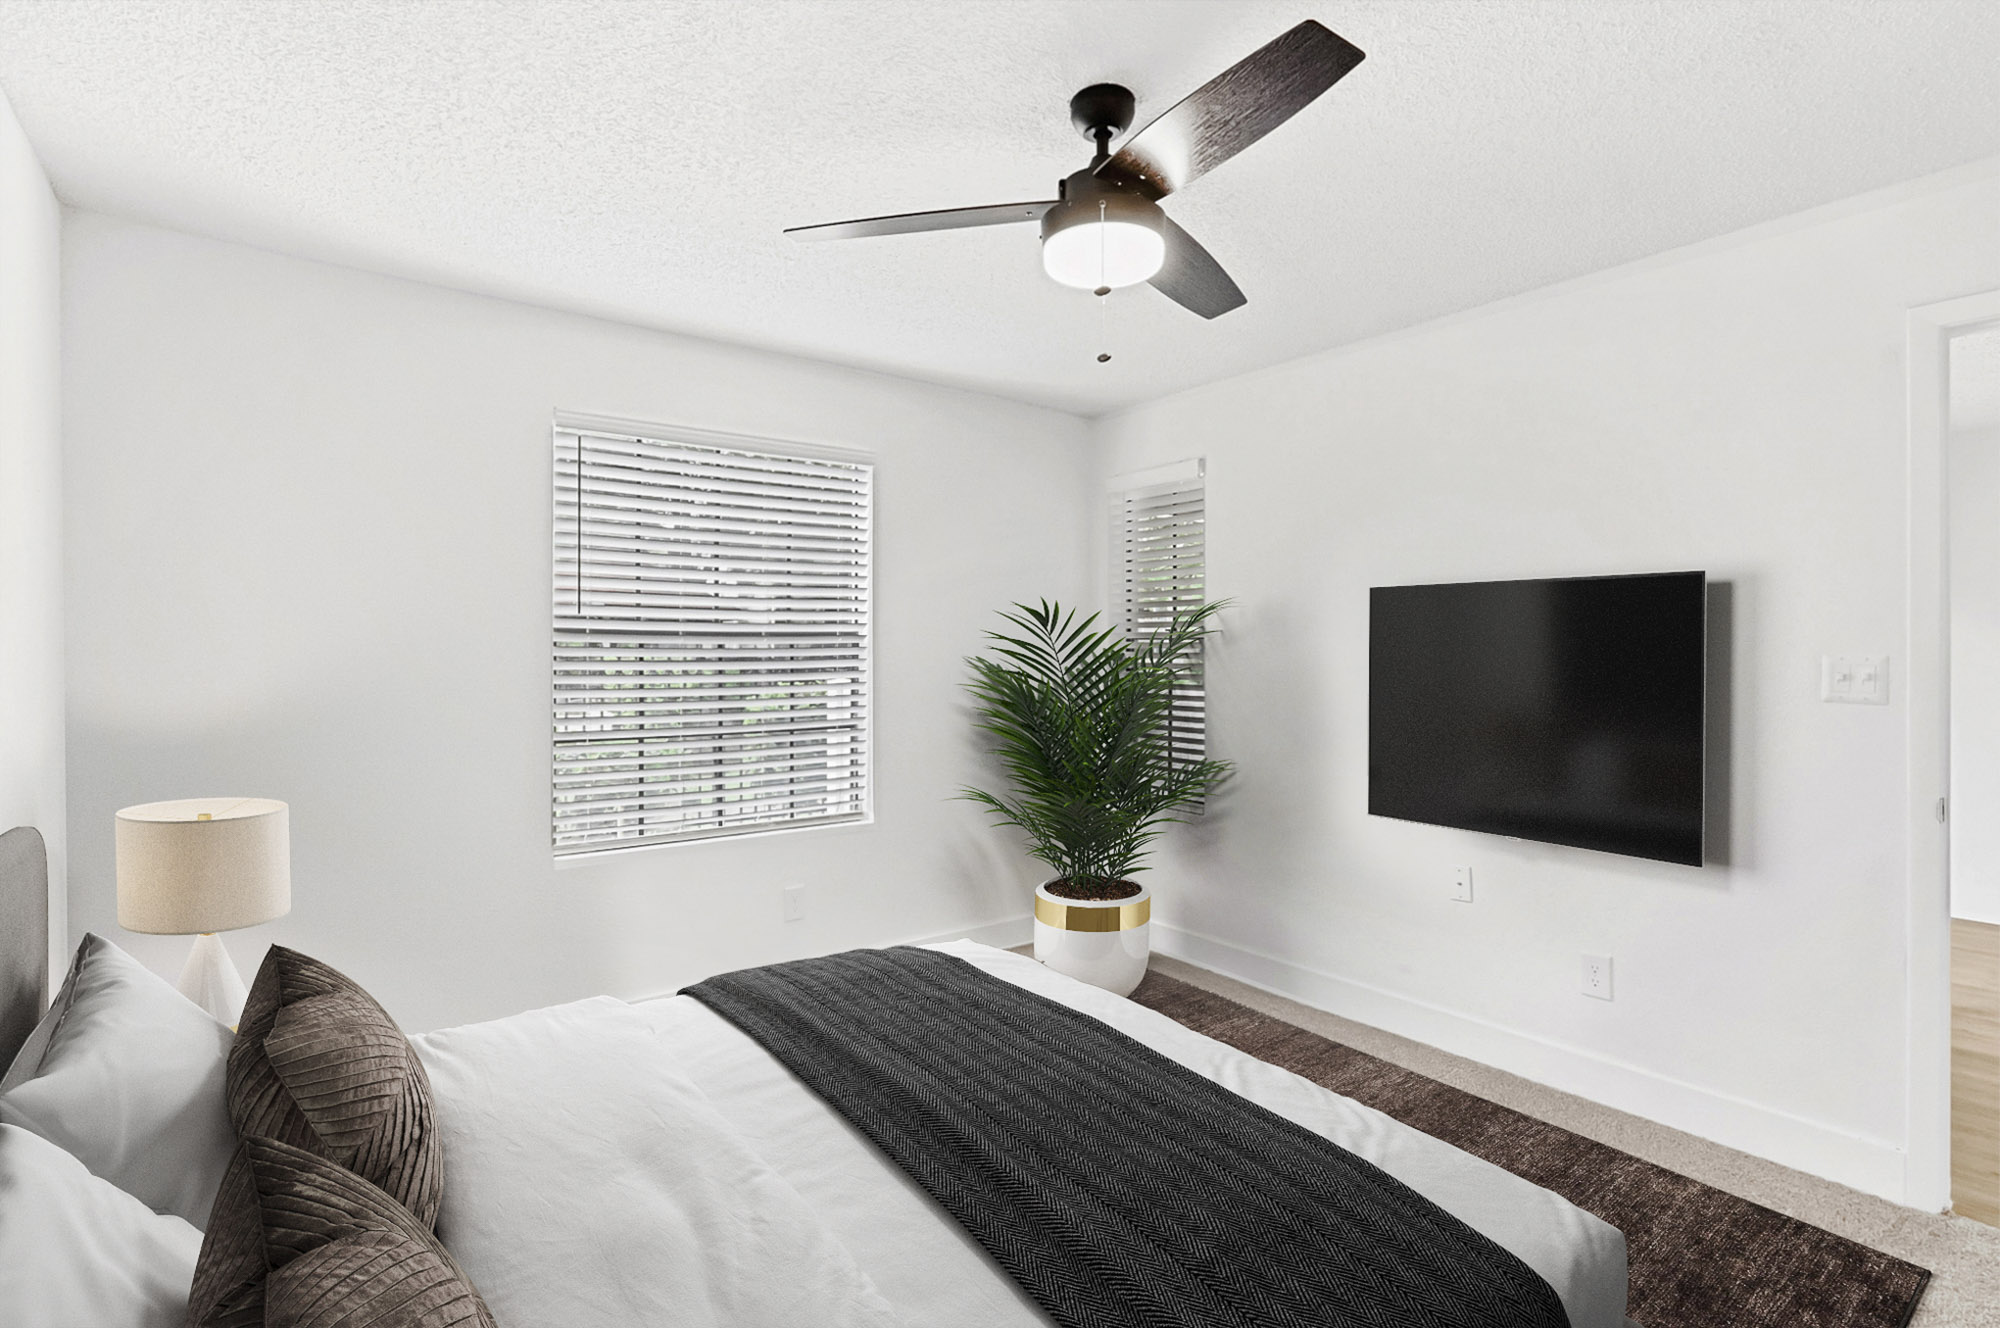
top-left (1946, 428), bottom-right (2000, 924)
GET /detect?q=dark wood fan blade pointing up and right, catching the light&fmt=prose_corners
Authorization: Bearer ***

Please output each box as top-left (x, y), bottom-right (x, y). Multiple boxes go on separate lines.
top-left (1098, 18), bottom-right (1362, 198)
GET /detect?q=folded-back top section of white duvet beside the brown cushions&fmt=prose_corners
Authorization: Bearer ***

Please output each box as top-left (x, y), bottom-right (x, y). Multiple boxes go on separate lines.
top-left (410, 996), bottom-right (898, 1328)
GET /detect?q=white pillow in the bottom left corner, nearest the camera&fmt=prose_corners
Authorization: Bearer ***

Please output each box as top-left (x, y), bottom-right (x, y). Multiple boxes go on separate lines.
top-left (0, 1126), bottom-right (202, 1328)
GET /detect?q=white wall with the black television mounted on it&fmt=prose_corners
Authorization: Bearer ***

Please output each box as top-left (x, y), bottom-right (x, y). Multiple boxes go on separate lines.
top-left (1098, 172), bottom-right (2000, 1196)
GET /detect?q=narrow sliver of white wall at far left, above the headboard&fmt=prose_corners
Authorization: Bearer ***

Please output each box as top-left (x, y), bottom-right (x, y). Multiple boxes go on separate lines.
top-left (0, 96), bottom-right (66, 980)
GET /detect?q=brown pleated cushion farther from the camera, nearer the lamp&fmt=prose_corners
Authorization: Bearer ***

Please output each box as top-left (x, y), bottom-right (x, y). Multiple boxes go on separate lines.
top-left (218, 946), bottom-right (444, 1230)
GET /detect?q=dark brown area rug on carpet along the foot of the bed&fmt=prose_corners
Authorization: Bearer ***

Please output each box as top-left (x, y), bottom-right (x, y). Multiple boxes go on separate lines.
top-left (1132, 972), bottom-right (1930, 1328)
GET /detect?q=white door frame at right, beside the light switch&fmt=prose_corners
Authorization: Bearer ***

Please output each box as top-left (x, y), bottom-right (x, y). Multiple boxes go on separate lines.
top-left (1904, 290), bottom-right (2000, 1212)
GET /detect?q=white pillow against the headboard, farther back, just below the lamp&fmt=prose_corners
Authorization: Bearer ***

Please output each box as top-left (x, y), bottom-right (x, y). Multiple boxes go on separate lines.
top-left (0, 936), bottom-right (236, 1228)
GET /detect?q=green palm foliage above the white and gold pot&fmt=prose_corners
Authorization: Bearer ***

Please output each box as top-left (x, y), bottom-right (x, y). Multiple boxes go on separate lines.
top-left (962, 600), bottom-right (1232, 882)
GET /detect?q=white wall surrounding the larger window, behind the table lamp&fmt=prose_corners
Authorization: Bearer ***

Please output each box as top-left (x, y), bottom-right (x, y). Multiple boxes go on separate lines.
top-left (64, 212), bottom-right (1090, 1028)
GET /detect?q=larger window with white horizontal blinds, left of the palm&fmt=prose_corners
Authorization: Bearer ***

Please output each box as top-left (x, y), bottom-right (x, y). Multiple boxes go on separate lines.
top-left (554, 420), bottom-right (874, 854)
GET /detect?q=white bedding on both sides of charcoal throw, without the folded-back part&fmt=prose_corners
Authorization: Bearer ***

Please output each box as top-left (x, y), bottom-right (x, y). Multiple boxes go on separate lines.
top-left (638, 940), bottom-right (1626, 1328)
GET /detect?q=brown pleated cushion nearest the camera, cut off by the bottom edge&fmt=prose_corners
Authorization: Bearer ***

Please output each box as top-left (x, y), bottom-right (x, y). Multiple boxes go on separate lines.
top-left (188, 1136), bottom-right (494, 1328)
